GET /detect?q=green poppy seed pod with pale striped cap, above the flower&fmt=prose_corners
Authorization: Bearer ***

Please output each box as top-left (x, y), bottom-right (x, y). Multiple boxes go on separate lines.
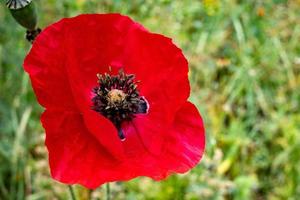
top-left (6, 0), bottom-right (37, 30)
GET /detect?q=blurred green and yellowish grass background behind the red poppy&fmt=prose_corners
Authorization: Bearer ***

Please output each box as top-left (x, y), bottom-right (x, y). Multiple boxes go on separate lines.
top-left (0, 0), bottom-right (300, 200)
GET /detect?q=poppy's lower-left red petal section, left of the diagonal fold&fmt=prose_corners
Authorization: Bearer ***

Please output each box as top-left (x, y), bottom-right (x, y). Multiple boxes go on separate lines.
top-left (41, 110), bottom-right (132, 188)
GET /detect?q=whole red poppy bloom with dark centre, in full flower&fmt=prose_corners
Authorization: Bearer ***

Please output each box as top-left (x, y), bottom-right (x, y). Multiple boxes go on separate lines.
top-left (24, 14), bottom-right (205, 188)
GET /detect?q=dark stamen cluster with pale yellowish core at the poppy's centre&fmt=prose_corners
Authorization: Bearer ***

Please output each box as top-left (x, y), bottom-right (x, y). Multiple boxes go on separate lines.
top-left (92, 70), bottom-right (149, 140)
